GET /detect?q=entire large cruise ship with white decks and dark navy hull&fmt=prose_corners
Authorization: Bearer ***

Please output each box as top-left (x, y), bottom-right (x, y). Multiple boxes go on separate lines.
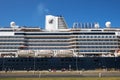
top-left (0, 15), bottom-right (120, 70)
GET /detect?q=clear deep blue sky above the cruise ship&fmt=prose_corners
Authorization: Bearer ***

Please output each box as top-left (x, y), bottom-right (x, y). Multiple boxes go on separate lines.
top-left (0, 0), bottom-right (120, 28)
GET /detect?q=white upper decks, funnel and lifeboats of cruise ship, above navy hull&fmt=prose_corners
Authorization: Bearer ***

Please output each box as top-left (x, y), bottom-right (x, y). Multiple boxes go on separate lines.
top-left (0, 15), bottom-right (120, 57)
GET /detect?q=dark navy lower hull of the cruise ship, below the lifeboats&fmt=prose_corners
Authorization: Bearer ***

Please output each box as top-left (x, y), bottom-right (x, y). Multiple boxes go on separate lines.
top-left (0, 57), bottom-right (120, 70)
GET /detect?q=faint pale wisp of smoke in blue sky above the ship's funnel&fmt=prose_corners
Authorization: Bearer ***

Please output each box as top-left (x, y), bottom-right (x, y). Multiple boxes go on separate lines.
top-left (37, 3), bottom-right (50, 16)
